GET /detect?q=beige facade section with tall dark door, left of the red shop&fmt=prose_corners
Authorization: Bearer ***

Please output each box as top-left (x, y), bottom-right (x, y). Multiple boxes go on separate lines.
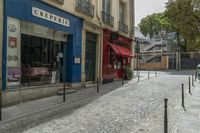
top-left (44, 0), bottom-right (103, 86)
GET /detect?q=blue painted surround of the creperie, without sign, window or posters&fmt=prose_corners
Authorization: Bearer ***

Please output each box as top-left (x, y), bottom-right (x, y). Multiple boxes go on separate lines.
top-left (2, 0), bottom-right (82, 89)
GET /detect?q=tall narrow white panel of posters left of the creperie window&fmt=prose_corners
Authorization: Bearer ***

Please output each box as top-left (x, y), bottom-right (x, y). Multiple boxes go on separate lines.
top-left (7, 17), bottom-right (21, 86)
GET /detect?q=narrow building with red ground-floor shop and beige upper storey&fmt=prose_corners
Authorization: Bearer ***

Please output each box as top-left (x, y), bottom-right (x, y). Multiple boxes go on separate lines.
top-left (100, 0), bottom-right (134, 82)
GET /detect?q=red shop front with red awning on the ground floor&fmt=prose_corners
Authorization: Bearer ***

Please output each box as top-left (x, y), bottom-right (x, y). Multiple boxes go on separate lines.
top-left (103, 29), bottom-right (133, 83)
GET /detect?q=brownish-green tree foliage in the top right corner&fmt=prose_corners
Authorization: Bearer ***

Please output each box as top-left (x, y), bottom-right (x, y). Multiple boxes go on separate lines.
top-left (165, 0), bottom-right (200, 51)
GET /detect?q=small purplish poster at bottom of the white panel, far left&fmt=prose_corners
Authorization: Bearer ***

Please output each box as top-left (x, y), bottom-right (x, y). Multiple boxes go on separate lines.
top-left (8, 67), bottom-right (20, 86)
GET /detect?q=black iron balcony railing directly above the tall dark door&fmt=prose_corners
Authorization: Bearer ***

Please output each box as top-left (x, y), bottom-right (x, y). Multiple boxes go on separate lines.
top-left (76, 0), bottom-right (94, 17)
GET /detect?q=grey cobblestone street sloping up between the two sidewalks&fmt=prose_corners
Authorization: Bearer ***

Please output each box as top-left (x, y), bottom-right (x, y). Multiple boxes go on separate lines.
top-left (24, 75), bottom-right (188, 133)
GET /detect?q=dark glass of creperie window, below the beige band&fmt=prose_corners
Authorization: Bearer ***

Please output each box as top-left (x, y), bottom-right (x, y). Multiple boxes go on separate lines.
top-left (21, 34), bottom-right (63, 85)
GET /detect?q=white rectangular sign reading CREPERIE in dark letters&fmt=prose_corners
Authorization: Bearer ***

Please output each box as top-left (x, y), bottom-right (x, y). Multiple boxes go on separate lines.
top-left (32, 7), bottom-right (70, 27)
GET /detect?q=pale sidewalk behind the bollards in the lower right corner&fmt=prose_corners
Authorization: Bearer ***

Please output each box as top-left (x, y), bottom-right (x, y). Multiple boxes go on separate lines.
top-left (174, 81), bottom-right (200, 133)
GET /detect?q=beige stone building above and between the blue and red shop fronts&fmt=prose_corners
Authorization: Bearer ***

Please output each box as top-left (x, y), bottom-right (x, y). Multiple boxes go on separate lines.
top-left (43, 0), bottom-right (134, 86)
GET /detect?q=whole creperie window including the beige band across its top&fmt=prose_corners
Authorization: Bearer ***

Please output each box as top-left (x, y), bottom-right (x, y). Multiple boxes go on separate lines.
top-left (21, 21), bottom-right (67, 86)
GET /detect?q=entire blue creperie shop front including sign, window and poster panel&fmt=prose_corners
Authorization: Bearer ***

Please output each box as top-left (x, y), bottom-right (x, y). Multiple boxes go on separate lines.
top-left (2, 0), bottom-right (82, 90)
